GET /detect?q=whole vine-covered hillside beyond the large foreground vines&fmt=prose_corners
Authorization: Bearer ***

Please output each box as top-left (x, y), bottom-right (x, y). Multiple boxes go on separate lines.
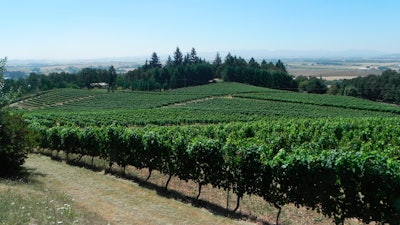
top-left (12, 82), bottom-right (400, 126)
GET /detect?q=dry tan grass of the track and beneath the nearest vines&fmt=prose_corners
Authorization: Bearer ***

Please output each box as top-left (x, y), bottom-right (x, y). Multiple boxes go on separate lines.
top-left (0, 154), bottom-right (376, 225)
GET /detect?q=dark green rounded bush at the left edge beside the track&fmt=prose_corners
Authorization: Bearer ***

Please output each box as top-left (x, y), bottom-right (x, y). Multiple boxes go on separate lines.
top-left (0, 110), bottom-right (33, 176)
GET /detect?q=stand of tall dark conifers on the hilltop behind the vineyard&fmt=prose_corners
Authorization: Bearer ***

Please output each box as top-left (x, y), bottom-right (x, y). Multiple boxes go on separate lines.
top-left (123, 47), bottom-right (297, 90)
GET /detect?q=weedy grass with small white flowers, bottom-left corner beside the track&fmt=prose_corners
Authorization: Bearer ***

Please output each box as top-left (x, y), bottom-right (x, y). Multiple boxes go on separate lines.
top-left (0, 164), bottom-right (107, 225)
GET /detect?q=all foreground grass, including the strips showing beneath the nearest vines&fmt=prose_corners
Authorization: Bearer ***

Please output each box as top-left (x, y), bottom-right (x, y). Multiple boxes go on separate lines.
top-left (0, 155), bottom-right (368, 225)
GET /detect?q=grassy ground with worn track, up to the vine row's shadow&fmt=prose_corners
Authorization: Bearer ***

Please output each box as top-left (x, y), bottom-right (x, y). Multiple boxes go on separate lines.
top-left (0, 155), bottom-right (253, 225)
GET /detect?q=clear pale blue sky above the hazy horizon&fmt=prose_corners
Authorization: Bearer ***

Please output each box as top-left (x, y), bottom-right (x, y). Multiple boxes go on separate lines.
top-left (0, 0), bottom-right (400, 59)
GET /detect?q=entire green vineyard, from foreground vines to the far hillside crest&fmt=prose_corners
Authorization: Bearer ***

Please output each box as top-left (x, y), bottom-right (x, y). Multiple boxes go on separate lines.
top-left (14, 83), bottom-right (400, 224)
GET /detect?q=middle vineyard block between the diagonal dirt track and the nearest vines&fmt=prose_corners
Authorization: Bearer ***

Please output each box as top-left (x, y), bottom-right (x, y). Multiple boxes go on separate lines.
top-left (24, 98), bottom-right (398, 127)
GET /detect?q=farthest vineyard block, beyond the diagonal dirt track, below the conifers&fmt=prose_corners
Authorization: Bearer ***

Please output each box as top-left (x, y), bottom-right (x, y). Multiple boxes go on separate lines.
top-left (19, 83), bottom-right (270, 111)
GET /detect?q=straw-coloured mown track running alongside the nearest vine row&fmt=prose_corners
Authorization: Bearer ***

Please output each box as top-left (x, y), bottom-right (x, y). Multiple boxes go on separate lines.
top-left (25, 155), bottom-right (248, 225)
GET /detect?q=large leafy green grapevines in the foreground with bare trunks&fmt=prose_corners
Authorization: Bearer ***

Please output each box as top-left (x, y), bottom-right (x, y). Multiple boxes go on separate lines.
top-left (31, 119), bottom-right (400, 224)
